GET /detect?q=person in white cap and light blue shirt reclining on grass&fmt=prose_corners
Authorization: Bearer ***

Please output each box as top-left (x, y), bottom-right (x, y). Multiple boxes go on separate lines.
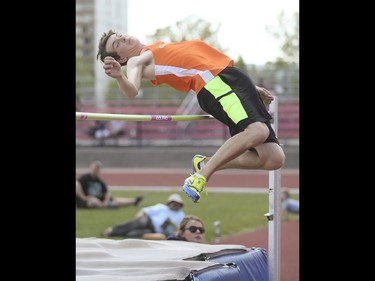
top-left (101, 193), bottom-right (185, 236)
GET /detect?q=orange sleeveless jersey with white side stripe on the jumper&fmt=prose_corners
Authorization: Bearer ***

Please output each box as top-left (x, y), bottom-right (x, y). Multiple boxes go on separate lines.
top-left (145, 39), bottom-right (233, 94)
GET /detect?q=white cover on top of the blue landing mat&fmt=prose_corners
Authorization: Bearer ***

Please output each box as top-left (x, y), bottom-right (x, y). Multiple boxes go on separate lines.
top-left (76, 238), bottom-right (247, 281)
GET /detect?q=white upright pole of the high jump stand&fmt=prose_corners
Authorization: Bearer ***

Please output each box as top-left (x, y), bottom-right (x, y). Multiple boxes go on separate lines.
top-left (265, 97), bottom-right (281, 281)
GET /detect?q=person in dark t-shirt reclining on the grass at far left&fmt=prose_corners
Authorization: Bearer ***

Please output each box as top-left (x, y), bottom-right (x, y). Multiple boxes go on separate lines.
top-left (76, 161), bottom-right (144, 208)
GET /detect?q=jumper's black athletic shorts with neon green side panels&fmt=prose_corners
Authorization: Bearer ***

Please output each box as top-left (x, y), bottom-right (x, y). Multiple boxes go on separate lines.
top-left (197, 67), bottom-right (279, 144)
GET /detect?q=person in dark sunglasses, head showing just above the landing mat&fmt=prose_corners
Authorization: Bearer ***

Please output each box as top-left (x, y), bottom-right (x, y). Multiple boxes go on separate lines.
top-left (167, 215), bottom-right (205, 243)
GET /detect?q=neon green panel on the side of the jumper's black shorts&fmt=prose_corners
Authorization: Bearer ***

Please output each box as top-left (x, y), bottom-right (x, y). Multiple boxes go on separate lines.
top-left (204, 76), bottom-right (248, 124)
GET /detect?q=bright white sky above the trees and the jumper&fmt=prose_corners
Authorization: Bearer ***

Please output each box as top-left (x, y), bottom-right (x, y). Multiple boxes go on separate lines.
top-left (128, 0), bottom-right (299, 65)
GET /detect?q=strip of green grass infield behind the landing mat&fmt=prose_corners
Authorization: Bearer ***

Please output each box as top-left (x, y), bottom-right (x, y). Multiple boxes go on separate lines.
top-left (76, 191), bottom-right (299, 242)
